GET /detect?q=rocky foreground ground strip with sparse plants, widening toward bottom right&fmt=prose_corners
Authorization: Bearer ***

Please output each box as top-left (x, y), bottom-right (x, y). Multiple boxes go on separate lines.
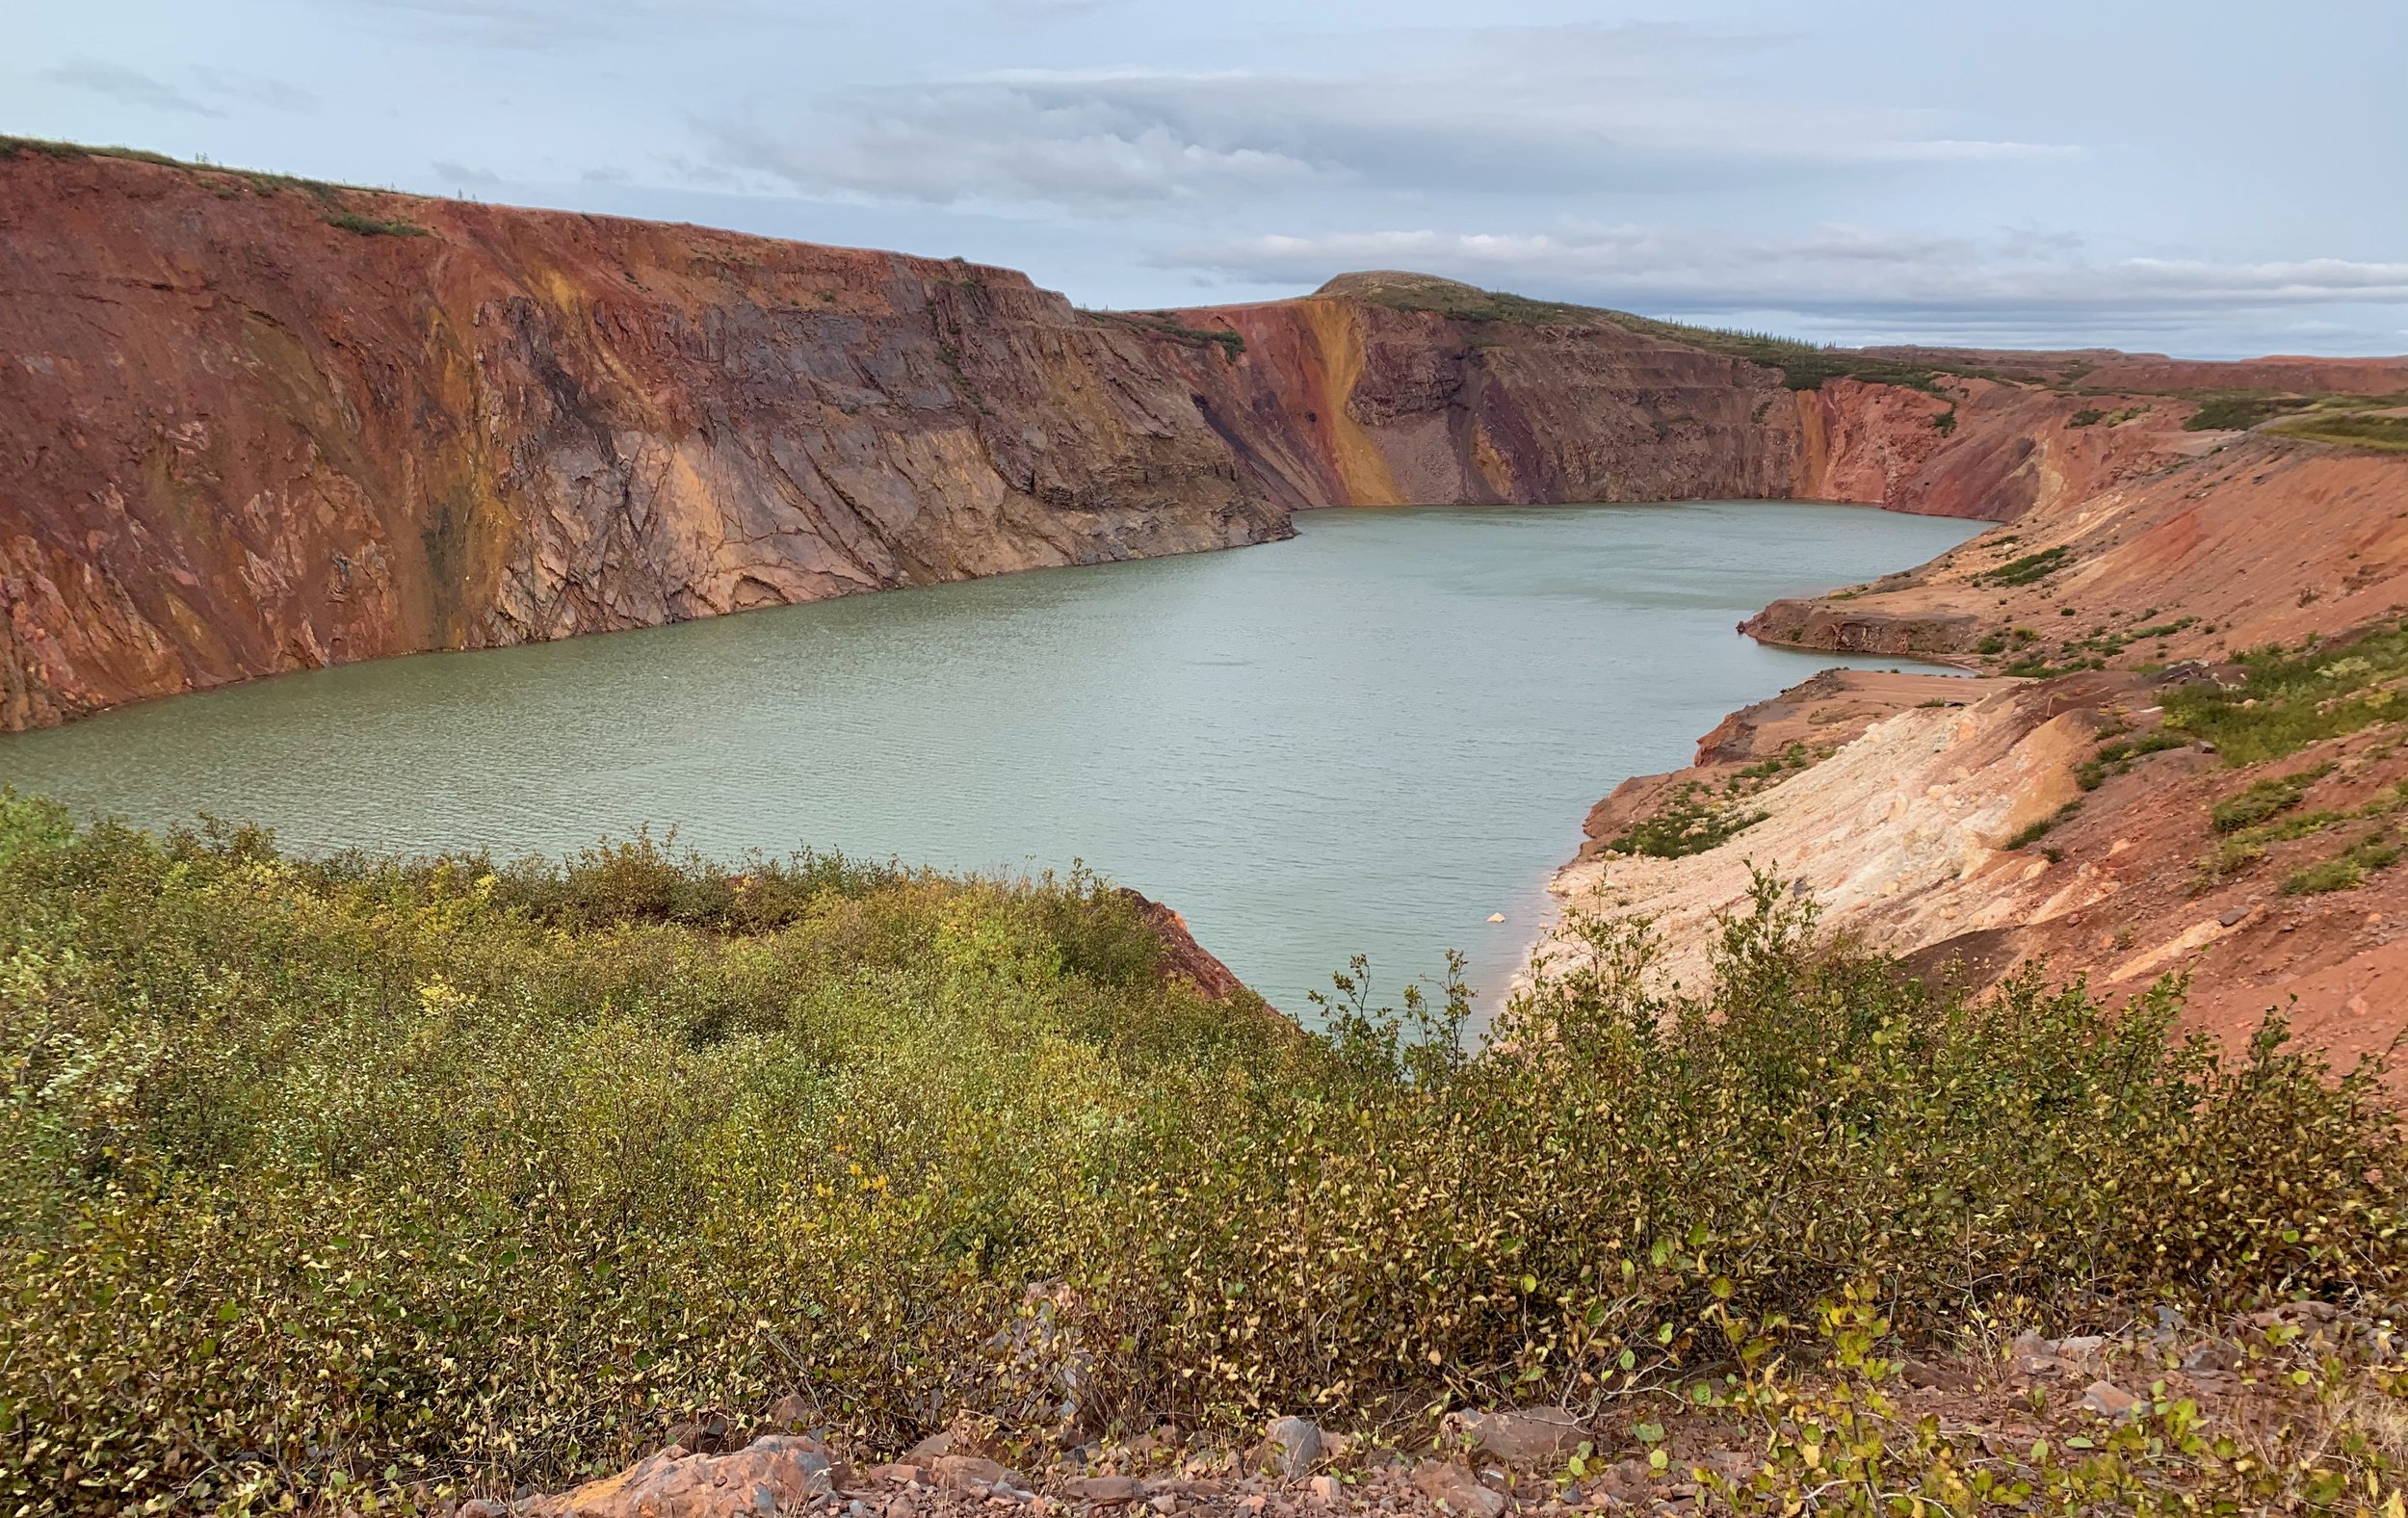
top-left (464, 1301), bottom-right (2408, 1518)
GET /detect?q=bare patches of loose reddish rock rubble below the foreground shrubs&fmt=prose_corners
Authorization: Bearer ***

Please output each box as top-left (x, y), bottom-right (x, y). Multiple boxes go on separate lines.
top-left (453, 1303), bottom-right (2389, 1518)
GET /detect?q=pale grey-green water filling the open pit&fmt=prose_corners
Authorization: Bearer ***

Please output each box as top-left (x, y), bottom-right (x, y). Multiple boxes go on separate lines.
top-left (0, 501), bottom-right (1975, 1012)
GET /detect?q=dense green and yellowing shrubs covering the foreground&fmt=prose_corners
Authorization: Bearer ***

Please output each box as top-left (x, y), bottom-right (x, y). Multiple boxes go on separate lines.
top-left (0, 798), bottom-right (2408, 1513)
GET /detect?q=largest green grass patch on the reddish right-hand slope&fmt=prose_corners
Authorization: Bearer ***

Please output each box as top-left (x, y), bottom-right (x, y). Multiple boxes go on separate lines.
top-left (2165, 624), bottom-right (2408, 767)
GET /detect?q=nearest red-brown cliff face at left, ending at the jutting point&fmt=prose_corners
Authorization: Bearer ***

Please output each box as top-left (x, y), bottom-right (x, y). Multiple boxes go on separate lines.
top-left (0, 149), bottom-right (1289, 727)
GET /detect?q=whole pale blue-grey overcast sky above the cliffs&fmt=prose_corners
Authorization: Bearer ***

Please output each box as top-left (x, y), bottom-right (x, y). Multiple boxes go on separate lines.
top-left (18, 0), bottom-right (2408, 356)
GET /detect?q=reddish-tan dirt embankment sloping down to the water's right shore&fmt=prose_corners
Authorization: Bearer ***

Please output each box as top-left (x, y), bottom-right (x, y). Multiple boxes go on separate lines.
top-left (1554, 436), bottom-right (2408, 1058)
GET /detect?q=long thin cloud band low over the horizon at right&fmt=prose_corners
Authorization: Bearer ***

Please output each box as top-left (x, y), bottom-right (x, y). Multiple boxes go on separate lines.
top-left (1159, 226), bottom-right (2408, 330)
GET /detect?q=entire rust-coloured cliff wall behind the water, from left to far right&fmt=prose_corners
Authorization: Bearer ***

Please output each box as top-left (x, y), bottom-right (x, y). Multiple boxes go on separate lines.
top-left (0, 140), bottom-right (2408, 730)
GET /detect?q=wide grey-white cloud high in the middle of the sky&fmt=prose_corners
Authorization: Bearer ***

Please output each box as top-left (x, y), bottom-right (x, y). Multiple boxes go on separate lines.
top-left (698, 27), bottom-right (2079, 215)
